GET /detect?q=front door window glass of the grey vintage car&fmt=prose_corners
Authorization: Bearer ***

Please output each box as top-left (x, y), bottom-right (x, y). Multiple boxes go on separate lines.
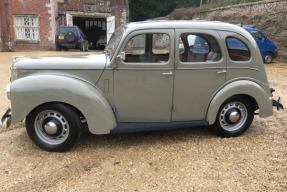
top-left (123, 33), bottom-right (170, 63)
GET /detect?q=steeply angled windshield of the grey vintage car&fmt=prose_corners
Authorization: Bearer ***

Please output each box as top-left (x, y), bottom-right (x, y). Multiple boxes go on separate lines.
top-left (104, 27), bottom-right (124, 58)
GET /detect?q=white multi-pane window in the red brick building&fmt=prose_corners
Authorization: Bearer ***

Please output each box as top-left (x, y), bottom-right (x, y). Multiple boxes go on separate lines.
top-left (15, 16), bottom-right (39, 41)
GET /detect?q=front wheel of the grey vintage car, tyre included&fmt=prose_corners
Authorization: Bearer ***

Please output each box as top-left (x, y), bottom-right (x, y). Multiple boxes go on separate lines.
top-left (26, 103), bottom-right (81, 152)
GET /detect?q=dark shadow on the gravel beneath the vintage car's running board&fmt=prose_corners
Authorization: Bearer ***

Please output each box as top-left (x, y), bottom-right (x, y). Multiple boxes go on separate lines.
top-left (74, 126), bottom-right (218, 152)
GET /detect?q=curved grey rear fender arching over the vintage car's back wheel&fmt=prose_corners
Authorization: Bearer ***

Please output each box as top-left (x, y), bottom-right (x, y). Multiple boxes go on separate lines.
top-left (206, 80), bottom-right (273, 124)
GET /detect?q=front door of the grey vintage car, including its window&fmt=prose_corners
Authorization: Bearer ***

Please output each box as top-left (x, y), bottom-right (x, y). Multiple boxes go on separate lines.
top-left (114, 29), bottom-right (174, 122)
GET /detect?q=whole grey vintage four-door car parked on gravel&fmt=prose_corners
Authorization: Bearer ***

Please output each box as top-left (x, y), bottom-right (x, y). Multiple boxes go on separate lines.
top-left (1, 21), bottom-right (283, 152)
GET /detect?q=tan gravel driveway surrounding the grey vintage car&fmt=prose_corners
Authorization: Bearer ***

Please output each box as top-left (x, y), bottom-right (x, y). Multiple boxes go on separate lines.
top-left (0, 52), bottom-right (287, 192)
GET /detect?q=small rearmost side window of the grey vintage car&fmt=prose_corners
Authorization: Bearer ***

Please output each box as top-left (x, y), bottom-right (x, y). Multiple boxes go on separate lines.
top-left (226, 37), bottom-right (251, 61)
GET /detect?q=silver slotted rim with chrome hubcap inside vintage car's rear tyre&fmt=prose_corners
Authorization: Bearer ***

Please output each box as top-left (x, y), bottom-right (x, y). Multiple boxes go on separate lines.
top-left (219, 102), bottom-right (248, 131)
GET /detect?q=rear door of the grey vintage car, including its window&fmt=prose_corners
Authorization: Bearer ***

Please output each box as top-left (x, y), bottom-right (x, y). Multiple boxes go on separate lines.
top-left (172, 29), bottom-right (226, 121)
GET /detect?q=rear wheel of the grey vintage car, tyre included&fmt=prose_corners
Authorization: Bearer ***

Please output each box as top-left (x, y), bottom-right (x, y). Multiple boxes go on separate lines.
top-left (214, 96), bottom-right (254, 137)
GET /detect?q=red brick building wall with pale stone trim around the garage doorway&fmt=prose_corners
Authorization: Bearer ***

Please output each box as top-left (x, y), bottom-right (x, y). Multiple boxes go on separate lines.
top-left (0, 0), bottom-right (128, 51)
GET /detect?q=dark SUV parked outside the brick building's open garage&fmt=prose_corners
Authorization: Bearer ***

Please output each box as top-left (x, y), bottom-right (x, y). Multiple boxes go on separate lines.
top-left (55, 26), bottom-right (89, 51)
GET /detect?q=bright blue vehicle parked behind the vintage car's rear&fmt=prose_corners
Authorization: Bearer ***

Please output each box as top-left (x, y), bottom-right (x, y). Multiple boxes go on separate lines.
top-left (242, 26), bottom-right (278, 64)
